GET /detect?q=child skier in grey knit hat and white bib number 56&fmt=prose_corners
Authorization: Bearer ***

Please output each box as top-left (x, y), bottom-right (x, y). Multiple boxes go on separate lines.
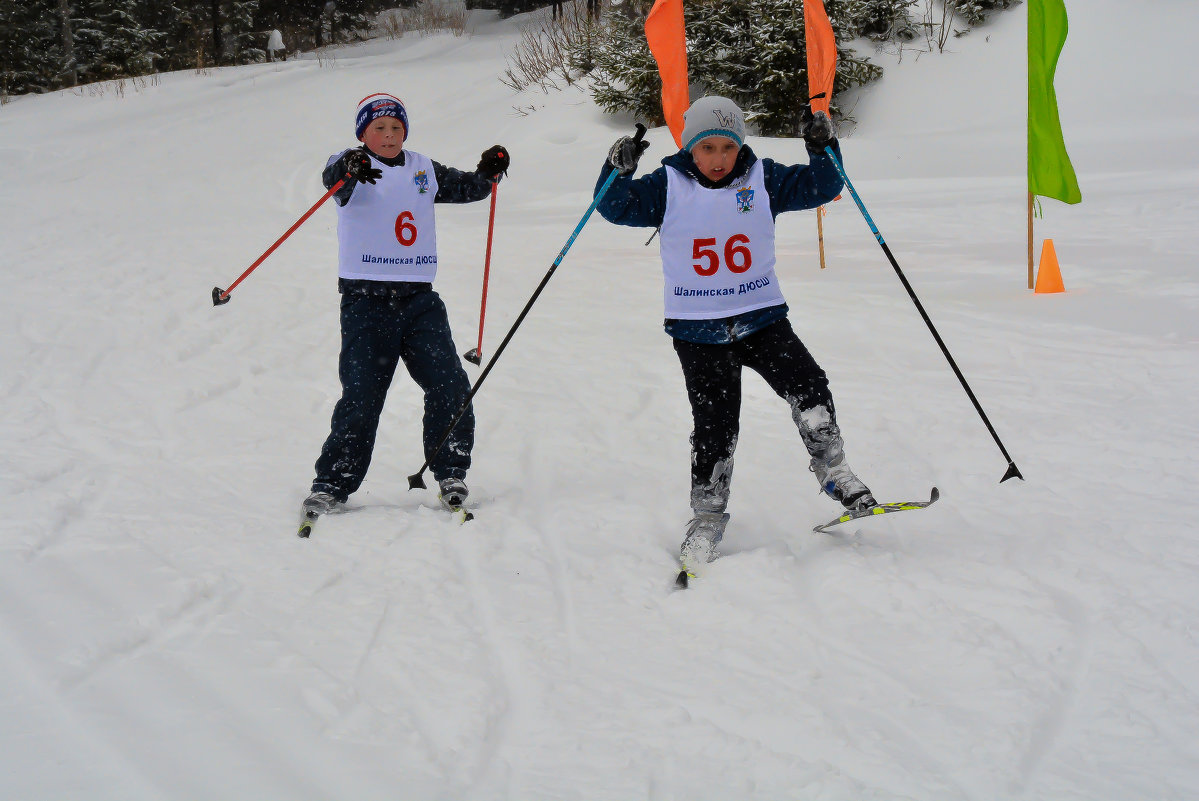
top-left (597, 97), bottom-right (876, 574)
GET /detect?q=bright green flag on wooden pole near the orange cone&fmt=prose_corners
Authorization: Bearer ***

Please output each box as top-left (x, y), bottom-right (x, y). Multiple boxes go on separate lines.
top-left (1028, 0), bottom-right (1083, 203)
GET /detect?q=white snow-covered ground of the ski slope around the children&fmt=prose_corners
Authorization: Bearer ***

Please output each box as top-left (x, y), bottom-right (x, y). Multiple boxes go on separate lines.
top-left (0, 0), bottom-right (1199, 801)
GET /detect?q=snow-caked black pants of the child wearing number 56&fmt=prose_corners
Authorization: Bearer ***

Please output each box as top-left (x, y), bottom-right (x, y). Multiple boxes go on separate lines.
top-left (674, 319), bottom-right (840, 512)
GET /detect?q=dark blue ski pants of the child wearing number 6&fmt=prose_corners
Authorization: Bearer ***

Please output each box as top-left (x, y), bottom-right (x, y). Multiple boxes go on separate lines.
top-left (312, 289), bottom-right (475, 502)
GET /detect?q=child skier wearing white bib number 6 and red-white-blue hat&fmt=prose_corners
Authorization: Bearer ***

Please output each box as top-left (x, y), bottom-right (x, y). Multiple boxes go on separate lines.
top-left (303, 94), bottom-right (510, 517)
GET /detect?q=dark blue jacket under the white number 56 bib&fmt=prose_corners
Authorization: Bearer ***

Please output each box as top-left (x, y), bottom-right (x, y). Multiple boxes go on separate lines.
top-left (595, 141), bottom-right (844, 344)
